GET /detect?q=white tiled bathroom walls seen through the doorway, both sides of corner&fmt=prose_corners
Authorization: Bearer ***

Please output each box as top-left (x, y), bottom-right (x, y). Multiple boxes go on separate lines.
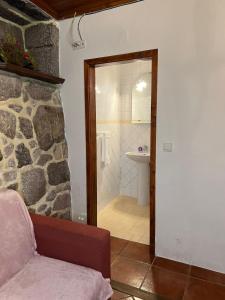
top-left (96, 61), bottom-right (151, 210)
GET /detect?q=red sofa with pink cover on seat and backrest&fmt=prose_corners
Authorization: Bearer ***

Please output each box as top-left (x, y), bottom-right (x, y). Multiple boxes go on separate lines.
top-left (0, 190), bottom-right (112, 300)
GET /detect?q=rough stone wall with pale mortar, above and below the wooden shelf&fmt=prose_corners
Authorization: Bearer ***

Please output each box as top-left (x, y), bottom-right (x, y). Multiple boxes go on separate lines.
top-left (0, 20), bottom-right (71, 219)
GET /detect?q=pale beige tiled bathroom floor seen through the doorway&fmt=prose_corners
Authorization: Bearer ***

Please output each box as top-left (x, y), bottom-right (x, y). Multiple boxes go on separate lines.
top-left (98, 196), bottom-right (150, 245)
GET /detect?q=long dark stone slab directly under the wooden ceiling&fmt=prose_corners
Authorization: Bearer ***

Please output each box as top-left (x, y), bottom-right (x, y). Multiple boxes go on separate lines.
top-left (4, 0), bottom-right (51, 21)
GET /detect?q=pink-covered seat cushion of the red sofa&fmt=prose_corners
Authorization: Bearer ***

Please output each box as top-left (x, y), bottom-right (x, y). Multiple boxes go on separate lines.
top-left (0, 255), bottom-right (112, 300)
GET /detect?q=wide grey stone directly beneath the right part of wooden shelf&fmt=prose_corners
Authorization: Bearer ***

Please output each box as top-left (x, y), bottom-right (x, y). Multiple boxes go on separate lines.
top-left (26, 82), bottom-right (54, 104)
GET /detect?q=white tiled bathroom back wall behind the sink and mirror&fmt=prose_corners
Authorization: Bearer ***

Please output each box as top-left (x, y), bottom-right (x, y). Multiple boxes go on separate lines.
top-left (120, 60), bottom-right (151, 198)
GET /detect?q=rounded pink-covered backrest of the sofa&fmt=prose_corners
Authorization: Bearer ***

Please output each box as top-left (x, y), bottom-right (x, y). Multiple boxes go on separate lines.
top-left (0, 190), bottom-right (36, 286)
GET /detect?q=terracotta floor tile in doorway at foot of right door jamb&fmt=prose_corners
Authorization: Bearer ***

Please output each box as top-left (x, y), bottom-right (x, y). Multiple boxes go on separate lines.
top-left (120, 242), bottom-right (154, 263)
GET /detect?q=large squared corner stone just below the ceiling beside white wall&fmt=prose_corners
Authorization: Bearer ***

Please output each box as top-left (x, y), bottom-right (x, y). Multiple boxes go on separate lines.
top-left (25, 23), bottom-right (59, 49)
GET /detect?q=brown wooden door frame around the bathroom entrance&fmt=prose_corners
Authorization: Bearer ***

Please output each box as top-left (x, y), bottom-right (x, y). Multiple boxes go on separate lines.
top-left (84, 49), bottom-right (158, 255)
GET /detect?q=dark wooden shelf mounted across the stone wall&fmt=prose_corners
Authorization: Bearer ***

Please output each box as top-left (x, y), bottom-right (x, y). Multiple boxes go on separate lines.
top-left (0, 62), bottom-right (65, 84)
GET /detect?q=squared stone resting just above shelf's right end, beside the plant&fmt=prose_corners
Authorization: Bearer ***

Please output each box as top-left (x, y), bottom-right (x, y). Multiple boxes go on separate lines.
top-left (30, 47), bottom-right (59, 76)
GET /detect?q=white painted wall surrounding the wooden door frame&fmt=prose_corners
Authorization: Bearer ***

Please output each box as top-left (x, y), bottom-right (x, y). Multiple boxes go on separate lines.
top-left (60, 0), bottom-right (225, 272)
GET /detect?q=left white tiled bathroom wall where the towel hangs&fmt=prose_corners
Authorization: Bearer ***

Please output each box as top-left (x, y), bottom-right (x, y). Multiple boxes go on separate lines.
top-left (96, 66), bottom-right (120, 210)
